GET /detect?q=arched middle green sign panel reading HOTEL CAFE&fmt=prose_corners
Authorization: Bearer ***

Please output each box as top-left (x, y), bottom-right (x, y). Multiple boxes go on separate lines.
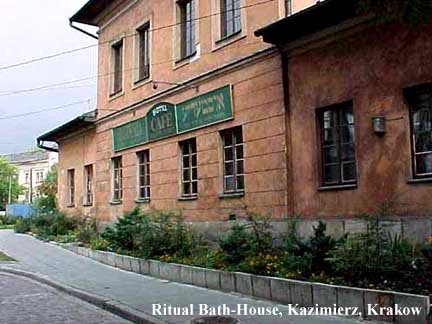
top-left (147, 102), bottom-right (177, 141)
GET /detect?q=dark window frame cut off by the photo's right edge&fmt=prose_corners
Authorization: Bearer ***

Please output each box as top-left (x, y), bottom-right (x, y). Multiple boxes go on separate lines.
top-left (404, 83), bottom-right (432, 180)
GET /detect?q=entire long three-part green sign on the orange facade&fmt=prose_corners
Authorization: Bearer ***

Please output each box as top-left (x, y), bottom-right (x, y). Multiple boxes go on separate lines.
top-left (113, 85), bottom-right (233, 151)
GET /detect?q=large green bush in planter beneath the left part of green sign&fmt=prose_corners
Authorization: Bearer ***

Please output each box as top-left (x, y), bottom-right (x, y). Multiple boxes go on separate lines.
top-left (102, 208), bottom-right (203, 258)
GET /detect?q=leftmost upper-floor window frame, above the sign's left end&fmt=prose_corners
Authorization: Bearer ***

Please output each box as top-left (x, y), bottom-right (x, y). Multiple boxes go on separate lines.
top-left (110, 38), bottom-right (125, 97)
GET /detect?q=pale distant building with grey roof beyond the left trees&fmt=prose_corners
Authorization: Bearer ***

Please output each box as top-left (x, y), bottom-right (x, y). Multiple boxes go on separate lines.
top-left (5, 151), bottom-right (58, 203)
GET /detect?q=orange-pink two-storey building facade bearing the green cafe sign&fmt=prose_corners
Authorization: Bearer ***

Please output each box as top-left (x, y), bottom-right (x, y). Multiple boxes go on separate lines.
top-left (39, 0), bottom-right (318, 222)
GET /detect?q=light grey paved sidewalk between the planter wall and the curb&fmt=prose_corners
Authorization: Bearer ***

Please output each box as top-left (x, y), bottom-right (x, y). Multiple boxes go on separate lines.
top-left (0, 231), bottom-right (371, 324)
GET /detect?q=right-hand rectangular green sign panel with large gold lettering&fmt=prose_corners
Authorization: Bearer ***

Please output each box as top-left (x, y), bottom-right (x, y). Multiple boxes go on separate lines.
top-left (176, 85), bottom-right (233, 133)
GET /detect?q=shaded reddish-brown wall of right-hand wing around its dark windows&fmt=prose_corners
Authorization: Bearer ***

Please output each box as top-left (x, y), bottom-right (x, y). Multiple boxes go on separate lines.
top-left (288, 25), bottom-right (432, 217)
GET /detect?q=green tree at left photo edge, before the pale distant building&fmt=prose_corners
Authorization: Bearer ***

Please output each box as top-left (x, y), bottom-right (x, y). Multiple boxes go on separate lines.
top-left (0, 157), bottom-right (22, 210)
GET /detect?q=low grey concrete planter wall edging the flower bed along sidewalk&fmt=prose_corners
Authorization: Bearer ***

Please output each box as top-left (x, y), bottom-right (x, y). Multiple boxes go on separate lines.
top-left (63, 244), bottom-right (430, 324)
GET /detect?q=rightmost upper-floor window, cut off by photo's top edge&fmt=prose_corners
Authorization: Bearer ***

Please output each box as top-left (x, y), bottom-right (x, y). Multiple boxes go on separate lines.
top-left (220, 0), bottom-right (241, 38)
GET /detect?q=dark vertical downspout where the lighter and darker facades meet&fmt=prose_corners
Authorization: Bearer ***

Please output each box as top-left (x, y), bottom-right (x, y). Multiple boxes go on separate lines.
top-left (278, 52), bottom-right (296, 217)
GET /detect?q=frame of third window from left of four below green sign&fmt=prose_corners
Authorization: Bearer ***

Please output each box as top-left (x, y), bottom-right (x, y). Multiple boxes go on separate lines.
top-left (179, 137), bottom-right (199, 198)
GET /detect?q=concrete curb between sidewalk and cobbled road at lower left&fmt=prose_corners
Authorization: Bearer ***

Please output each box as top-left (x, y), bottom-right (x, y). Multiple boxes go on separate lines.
top-left (0, 267), bottom-right (168, 324)
